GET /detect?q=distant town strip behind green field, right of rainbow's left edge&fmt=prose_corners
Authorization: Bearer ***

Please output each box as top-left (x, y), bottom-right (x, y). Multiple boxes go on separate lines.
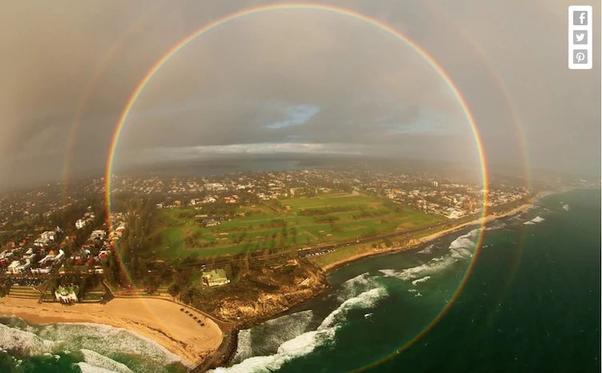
top-left (111, 170), bottom-right (528, 219)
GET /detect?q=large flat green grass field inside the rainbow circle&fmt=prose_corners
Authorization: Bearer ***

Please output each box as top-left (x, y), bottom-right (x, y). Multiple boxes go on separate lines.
top-left (151, 193), bottom-right (443, 259)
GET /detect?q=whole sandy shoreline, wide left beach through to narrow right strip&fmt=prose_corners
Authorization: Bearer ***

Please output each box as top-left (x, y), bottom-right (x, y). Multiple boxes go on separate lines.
top-left (0, 191), bottom-right (554, 371)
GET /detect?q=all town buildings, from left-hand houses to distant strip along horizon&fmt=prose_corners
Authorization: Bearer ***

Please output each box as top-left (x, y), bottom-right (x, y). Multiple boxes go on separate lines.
top-left (0, 169), bottom-right (530, 299)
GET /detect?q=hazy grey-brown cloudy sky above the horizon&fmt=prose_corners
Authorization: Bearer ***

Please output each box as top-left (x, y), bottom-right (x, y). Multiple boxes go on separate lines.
top-left (0, 0), bottom-right (600, 188)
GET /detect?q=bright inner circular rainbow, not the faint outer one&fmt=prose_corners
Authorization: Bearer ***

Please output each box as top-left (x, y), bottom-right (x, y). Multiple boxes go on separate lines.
top-left (105, 3), bottom-right (489, 363)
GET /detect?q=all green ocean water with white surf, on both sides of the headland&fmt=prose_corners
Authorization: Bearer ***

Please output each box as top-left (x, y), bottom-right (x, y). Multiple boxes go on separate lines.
top-left (0, 190), bottom-right (601, 372)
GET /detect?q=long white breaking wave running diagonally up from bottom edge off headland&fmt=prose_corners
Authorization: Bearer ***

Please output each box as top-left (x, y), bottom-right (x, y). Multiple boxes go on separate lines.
top-left (214, 273), bottom-right (387, 372)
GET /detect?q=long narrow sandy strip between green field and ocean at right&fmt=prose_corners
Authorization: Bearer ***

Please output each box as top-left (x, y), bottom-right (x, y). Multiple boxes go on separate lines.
top-left (322, 198), bottom-right (537, 271)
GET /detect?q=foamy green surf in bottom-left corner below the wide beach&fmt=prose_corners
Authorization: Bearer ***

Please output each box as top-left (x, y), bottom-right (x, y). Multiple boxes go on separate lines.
top-left (0, 317), bottom-right (187, 373)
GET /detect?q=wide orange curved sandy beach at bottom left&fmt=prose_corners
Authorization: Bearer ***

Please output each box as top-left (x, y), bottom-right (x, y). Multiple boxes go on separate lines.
top-left (0, 297), bottom-right (223, 366)
